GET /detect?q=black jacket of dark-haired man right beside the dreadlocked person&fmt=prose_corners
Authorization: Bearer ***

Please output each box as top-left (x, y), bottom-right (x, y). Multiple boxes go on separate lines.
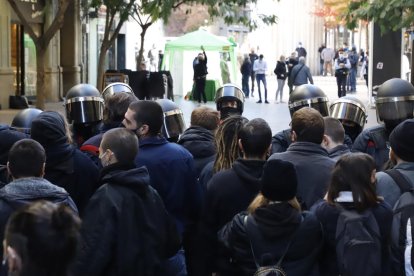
top-left (195, 159), bottom-right (265, 275)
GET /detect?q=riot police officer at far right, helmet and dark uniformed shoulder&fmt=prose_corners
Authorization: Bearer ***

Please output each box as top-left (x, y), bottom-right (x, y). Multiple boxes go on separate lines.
top-left (352, 78), bottom-right (414, 171)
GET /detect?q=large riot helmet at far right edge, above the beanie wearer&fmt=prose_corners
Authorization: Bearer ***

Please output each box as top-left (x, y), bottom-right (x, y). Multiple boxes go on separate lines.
top-left (376, 78), bottom-right (414, 131)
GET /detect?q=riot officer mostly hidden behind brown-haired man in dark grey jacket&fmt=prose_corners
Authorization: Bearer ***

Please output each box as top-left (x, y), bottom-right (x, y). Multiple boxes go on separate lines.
top-left (272, 84), bottom-right (329, 153)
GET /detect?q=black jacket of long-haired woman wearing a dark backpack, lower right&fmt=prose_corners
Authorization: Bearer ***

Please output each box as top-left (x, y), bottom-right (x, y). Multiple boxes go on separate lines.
top-left (311, 200), bottom-right (392, 276)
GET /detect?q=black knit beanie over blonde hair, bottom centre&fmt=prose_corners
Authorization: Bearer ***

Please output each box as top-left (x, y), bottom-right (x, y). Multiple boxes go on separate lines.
top-left (261, 159), bottom-right (298, 201)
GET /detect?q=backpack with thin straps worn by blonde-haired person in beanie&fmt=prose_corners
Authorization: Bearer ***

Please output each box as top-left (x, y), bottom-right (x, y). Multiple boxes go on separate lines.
top-left (244, 216), bottom-right (300, 276)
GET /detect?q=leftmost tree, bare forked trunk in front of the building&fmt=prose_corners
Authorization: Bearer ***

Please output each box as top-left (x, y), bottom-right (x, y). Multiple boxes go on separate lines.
top-left (7, 0), bottom-right (71, 109)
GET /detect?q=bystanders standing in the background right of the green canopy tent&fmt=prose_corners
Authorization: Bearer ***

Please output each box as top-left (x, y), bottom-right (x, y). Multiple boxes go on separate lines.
top-left (240, 42), bottom-right (368, 103)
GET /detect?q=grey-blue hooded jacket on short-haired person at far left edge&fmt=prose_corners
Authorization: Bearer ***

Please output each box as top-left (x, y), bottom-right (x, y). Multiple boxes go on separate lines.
top-left (0, 177), bottom-right (78, 256)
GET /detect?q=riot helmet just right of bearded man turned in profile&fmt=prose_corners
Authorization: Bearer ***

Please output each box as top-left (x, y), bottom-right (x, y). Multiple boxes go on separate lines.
top-left (157, 99), bottom-right (185, 142)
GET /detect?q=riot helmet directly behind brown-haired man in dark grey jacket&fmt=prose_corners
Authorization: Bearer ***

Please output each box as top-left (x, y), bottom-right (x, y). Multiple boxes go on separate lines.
top-left (288, 84), bottom-right (329, 117)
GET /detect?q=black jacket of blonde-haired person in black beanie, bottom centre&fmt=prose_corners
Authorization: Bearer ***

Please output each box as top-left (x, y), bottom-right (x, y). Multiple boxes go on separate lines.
top-left (218, 202), bottom-right (323, 276)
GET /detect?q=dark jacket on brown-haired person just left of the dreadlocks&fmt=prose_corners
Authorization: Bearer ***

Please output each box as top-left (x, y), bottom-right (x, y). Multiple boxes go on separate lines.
top-left (178, 126), bottom-right (216, 178)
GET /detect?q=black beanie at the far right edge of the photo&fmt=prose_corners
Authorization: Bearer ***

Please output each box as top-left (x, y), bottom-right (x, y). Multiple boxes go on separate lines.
top-left (390, 119), bottom-right (414, 162)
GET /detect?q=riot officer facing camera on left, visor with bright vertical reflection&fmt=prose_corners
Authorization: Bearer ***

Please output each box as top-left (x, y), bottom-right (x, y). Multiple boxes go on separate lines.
top-left (65, 83), bottom-right (104, 145)
